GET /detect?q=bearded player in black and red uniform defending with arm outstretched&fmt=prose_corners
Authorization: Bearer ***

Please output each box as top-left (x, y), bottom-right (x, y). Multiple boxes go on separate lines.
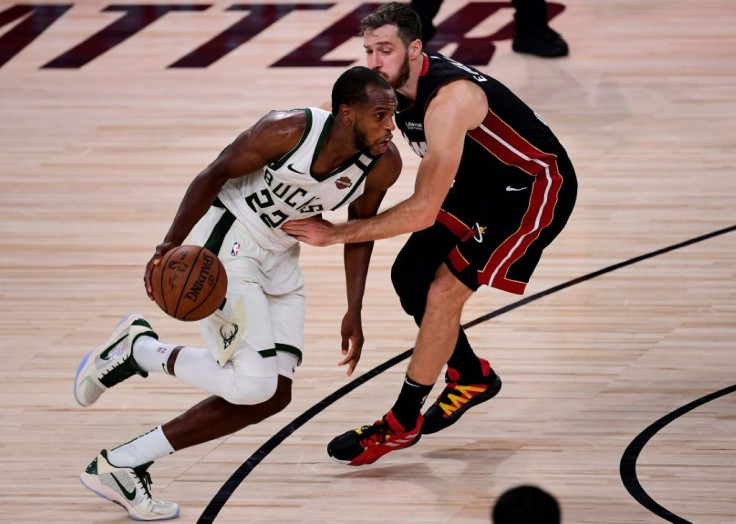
top-left (284, 2), bottom-right (577, 465)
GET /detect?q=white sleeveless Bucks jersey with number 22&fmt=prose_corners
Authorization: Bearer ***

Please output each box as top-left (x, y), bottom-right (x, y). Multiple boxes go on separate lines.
top-left (218, 107), bottom-right (377, 251)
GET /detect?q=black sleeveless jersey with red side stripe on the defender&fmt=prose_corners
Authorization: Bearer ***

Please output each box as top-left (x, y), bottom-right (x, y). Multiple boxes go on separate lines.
top-left (396, 52), bottom-right (574, 224)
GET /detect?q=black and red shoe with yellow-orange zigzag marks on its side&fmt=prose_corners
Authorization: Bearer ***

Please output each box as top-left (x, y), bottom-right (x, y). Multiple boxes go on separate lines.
top-left (422, 358), bottom-right (501, 435)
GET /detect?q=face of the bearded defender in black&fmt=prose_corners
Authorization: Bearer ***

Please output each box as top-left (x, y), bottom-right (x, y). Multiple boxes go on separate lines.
top-left (363, 25), bottom-right (409, 89)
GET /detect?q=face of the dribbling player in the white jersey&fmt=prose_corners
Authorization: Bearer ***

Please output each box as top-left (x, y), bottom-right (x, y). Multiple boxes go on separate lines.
top-left (353, 87), bottom-right (397, 156)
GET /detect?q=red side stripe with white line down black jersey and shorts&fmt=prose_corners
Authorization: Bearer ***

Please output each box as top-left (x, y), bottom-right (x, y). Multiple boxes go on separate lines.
top-left (468, 109), bottom-right (562, 294)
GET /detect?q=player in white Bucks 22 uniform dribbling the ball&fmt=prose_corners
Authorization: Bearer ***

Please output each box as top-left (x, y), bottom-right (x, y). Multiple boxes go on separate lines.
top-left (74, 67), bottom-right (401, 520)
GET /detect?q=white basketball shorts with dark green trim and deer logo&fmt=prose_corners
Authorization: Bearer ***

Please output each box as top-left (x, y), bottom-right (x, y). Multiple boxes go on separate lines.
top-left (191, 206), bottom-right (304, 378)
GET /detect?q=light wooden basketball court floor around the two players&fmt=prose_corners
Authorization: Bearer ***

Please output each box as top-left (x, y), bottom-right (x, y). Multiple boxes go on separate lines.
top-left (0, 0), bottom-right (736, 523)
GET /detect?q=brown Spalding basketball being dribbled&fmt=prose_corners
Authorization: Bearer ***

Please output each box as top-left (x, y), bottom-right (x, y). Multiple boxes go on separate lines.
top-left (151, 245), bottom-right (227, 321)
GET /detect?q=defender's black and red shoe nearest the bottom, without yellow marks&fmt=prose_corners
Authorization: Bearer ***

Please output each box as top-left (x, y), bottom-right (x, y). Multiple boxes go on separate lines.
top-left (327, 411), bottom-right (422, 466)
